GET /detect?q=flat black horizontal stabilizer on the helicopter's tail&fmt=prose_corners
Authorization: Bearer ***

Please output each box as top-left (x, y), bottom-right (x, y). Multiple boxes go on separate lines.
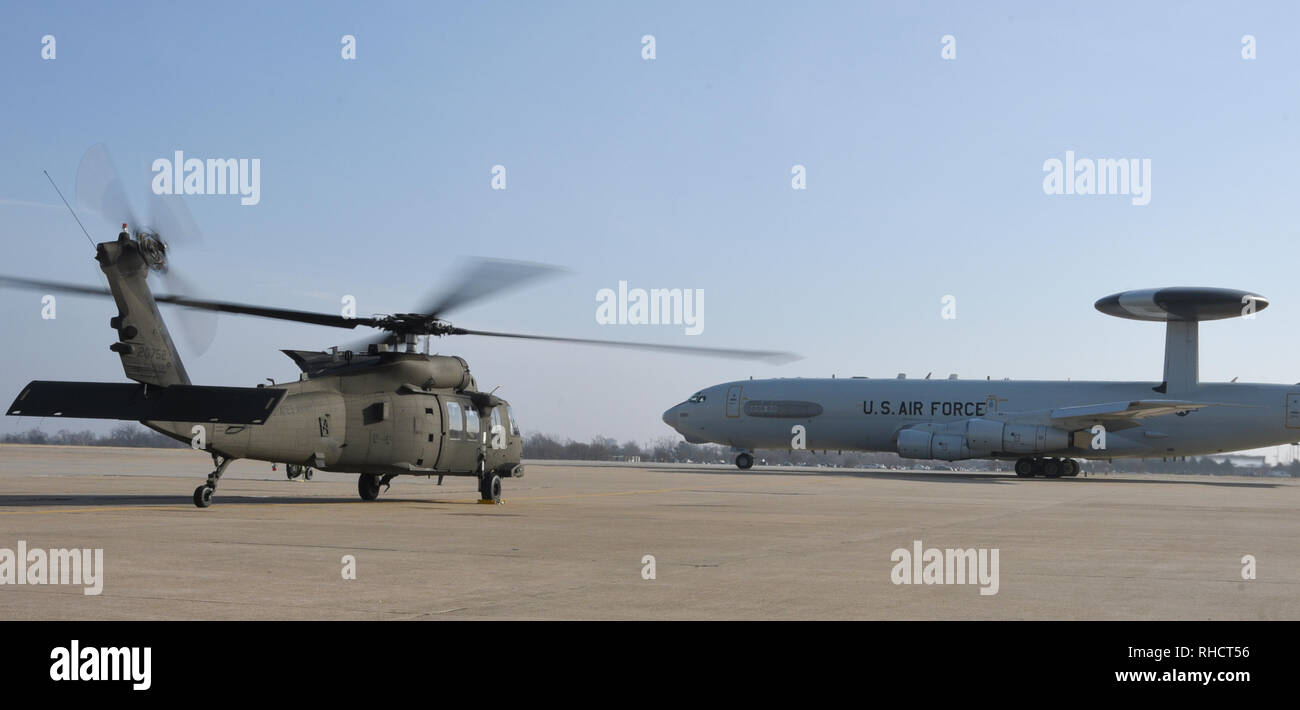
top-left (8, 380), bottom-right (285, 424)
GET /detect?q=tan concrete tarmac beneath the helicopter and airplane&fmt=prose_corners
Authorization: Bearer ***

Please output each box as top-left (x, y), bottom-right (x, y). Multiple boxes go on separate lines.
top-left (0, 445), bottom-right (1300, 619)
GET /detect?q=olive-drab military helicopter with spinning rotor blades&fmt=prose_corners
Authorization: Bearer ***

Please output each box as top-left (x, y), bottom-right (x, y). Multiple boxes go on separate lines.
top-left (0, 148), bottom-right (793, 508)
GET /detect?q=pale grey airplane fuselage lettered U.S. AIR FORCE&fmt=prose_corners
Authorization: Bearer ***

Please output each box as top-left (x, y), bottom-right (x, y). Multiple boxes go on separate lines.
top-left (663, 378), bottom-right (1300, 460)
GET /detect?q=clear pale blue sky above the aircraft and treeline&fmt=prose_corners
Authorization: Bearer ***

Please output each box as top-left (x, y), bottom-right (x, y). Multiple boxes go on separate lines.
top-left (0, 1), bottom-right (1300, 441)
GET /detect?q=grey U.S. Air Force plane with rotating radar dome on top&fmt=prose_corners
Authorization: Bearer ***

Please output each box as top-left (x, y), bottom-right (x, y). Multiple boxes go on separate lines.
top-left (663, 287), bottom-right (1300, 479)
